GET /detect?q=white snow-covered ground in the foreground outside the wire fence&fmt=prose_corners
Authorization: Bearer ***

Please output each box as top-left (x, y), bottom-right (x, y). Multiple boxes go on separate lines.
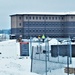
top-left (0, 40), bottom-right (75, 75)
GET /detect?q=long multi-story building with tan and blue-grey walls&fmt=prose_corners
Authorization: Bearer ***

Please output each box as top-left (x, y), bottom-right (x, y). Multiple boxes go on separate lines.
top-left (11, 13), bottom-right (75, 38)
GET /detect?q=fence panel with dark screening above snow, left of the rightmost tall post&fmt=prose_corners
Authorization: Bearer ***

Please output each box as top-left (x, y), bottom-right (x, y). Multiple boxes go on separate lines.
top-left (50, 45), bottom-right (71, 64)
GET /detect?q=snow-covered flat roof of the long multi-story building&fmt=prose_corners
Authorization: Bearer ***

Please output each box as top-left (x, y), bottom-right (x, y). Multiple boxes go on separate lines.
top-left (10, 12), bottom-right (75, 16)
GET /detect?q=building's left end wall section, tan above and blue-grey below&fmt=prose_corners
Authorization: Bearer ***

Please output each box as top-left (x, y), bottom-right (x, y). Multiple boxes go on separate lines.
top-left (11, 16), bottom-right (23, 38)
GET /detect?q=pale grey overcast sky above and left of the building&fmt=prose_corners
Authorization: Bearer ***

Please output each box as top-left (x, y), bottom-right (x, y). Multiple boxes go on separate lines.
top-left (0, 0), bottom-right (75, 29)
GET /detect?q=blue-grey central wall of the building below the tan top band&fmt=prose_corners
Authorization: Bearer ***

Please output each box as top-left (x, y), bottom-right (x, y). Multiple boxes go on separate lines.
top-left (24, 22), bottom-right (67, 37)
